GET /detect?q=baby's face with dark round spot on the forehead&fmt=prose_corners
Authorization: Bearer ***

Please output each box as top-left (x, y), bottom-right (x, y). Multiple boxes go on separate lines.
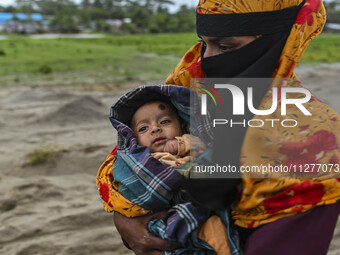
top-left (131, 101), bottom-right (182, 152)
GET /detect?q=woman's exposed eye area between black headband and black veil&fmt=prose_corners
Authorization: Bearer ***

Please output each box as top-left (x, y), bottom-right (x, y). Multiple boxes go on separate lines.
top-left (199, 36), bottom-right (256, 58)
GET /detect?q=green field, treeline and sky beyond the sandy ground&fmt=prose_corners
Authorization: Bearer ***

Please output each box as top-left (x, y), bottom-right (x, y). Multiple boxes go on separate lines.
top-left (0, 0), bottom-right (340, 86)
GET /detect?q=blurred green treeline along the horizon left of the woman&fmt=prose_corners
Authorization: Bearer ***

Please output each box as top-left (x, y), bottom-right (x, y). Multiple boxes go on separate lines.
top-left (0, 0), bottom-right (195, 34)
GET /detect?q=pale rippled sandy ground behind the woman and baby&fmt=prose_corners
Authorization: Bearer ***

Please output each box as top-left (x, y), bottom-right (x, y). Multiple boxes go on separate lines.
top-left (0, 64), bottom-right (340, 255)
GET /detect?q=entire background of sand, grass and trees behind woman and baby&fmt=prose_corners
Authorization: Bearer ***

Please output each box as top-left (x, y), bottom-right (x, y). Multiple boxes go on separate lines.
top-left (0, 0), bottom-right (340, 255)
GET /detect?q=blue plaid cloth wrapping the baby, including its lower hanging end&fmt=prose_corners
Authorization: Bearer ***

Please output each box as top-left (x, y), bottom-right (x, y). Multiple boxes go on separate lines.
top-left (110, 85), bottom-right (238, 255)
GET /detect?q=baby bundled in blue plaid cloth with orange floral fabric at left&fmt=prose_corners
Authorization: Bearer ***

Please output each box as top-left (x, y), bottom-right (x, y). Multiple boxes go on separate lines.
top-left (97, 85), bottom-right (236, 255)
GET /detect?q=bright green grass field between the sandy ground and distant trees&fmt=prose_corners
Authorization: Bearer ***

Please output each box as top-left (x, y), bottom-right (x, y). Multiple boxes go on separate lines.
top-left (0, 33), bottom-right (340, 85)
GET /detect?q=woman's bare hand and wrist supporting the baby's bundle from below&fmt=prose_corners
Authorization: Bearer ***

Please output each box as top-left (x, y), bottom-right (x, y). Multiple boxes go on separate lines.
top-left (113, 211), bottom-right (180, 255)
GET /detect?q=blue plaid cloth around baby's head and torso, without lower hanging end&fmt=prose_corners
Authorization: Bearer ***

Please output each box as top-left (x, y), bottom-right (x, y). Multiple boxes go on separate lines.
top-left (110, 85), bottom-right (209, 210)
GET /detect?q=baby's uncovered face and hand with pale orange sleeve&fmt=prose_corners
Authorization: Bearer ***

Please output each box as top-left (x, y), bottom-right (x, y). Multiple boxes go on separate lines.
top-left (130, 101), bottom-right (205, 167)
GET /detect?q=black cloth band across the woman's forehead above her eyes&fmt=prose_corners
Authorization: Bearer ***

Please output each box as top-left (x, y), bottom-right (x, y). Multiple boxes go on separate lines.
top-left (196, 1), bottom-right (304, 37)
